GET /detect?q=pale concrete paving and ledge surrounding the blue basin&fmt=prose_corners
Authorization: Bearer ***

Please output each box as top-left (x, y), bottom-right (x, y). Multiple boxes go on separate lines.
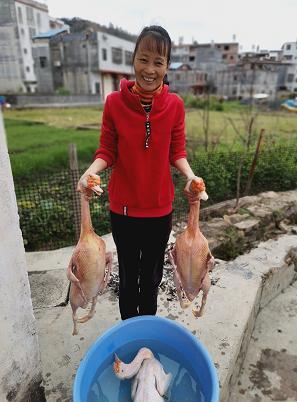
top-left (30, 231), bottom-right (297, 402)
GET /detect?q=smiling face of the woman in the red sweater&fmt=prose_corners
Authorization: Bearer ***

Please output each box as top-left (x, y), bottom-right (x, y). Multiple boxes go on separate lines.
top-left (134, 40), bottom-right (168, 92)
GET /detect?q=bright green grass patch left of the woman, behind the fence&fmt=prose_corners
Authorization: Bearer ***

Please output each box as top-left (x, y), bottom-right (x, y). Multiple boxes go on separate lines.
top-left (5, 119), bottom-right (98, 177)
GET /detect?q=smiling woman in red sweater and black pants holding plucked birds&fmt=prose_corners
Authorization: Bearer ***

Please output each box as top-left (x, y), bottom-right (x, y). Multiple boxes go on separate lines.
top-left (78, 25), bottom-right (198, 320)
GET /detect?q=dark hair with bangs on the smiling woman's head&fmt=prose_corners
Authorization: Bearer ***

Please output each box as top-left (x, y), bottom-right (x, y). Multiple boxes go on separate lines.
top-left (132, 25), bottom-right (171, 65)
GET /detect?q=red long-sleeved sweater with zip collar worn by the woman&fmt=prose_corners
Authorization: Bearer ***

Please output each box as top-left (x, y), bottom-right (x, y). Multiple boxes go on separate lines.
top-left (95, 79), bottom-right (186, 217)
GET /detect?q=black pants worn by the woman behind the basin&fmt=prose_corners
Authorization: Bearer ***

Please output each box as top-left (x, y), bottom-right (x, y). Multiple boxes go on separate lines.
top-left (110, 212), bottom-right (172, 320)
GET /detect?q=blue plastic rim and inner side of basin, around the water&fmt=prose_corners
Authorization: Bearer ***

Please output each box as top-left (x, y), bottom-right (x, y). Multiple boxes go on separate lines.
top-left (73, 315), bottom-right (219, 402)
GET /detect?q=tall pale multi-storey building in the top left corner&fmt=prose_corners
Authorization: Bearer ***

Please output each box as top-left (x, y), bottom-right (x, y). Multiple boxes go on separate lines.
top-left (0, 0), bottom-right (49, 93)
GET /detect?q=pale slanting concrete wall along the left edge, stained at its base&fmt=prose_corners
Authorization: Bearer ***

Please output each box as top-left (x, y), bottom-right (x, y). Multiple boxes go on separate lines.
top-left (0, 112), bottom-right (45, 402)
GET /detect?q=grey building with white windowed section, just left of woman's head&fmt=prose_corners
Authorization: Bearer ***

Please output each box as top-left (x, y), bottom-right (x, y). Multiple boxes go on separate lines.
top-left (33, 28), bottom-right (135, 99)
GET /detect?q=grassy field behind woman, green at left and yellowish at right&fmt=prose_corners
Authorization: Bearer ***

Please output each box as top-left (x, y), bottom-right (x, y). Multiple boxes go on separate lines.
top-left (4, 108), bottom-right (297, 177)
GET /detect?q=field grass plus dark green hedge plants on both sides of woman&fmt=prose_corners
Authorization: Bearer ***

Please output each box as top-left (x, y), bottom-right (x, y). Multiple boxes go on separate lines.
top-left (4, 103), bottom-right (297, 250)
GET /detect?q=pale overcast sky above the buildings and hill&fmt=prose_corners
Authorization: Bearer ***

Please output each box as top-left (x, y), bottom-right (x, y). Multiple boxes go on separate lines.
top-left (45, 0), bottom-right (297, 51)
